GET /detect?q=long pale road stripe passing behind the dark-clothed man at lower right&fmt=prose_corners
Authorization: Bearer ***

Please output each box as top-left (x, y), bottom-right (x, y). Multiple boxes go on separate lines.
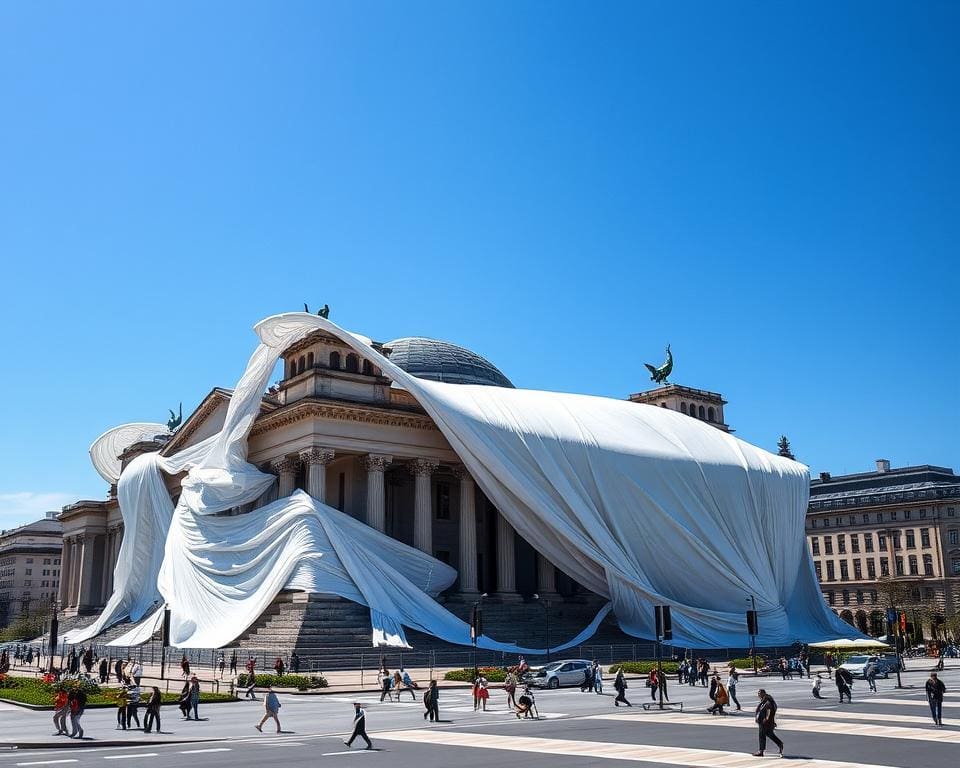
top-left (587, 712), bottom-right (960, 744)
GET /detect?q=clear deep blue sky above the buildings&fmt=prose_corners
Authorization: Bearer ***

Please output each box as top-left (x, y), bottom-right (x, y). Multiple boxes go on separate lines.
top-left (0, 0), bottom-right (960, 526)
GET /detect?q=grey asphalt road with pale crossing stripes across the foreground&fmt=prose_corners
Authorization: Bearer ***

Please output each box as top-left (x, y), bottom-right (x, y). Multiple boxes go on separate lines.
top-left (0, 663), bottom-right (960, 768)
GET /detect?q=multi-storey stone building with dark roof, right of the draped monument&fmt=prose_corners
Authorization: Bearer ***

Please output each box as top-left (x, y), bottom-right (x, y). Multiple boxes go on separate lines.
top-left (807, 459), bottom-right (960, 638)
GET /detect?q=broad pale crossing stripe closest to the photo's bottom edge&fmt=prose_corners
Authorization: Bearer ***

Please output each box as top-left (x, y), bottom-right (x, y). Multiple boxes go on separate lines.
top-left (374, 730), bottom-right (887, 768)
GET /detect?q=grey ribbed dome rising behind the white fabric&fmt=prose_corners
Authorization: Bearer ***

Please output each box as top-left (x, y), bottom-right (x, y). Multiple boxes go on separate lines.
top-left (384, 336), bottom-right (513, 388)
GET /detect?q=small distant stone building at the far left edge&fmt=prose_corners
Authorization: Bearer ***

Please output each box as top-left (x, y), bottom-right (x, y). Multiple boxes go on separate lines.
top-left (0, 512), bottom-right (62, 627)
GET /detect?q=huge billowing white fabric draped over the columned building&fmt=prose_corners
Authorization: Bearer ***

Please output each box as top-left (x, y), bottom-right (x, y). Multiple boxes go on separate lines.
top-left (68, 313), bottom-right (850, 647)
